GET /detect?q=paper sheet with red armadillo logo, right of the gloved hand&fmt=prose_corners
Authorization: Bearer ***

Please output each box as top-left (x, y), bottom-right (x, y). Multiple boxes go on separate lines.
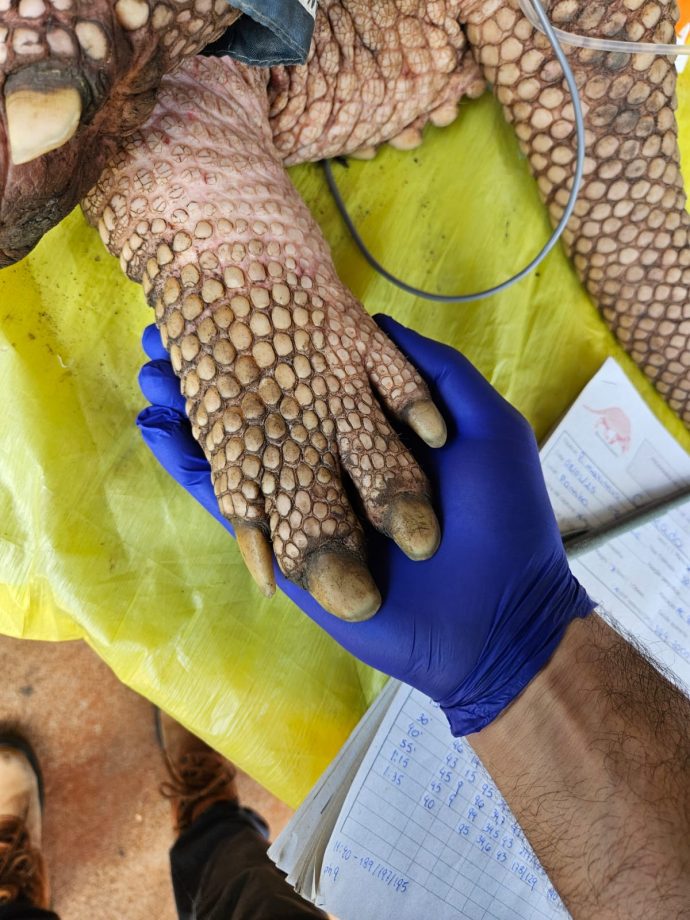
top-left (541, 358), bottom-right (690, 686)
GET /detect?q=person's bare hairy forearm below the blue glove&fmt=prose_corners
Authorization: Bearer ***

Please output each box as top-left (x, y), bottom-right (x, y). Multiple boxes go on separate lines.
top-left (470, 616), bottom-right (690, 920)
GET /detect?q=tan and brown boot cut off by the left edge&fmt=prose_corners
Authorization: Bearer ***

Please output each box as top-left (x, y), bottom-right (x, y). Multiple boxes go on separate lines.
top-left (0, 732), bottom-right (50, 908)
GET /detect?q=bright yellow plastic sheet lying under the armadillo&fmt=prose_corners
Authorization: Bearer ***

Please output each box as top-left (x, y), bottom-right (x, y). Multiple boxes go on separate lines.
top-left (0, 79), bottom-right (690, 805)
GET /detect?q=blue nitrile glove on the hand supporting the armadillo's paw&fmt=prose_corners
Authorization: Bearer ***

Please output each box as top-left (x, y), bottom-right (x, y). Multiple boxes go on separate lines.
top-left (138, 317), bottom-right (594, 734)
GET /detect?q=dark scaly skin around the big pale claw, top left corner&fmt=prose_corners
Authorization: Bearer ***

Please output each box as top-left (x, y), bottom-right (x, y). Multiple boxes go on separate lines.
top-left (0, 0), bottom-right (238, 267)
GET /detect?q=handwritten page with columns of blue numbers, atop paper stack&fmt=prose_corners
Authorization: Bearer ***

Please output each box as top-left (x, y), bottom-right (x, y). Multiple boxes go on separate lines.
top-left (319, 685), bottom-right (568, 920)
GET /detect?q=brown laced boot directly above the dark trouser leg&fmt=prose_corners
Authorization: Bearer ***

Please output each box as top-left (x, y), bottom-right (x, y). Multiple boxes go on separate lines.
top-left (156, 710), bottom-right (238, 835)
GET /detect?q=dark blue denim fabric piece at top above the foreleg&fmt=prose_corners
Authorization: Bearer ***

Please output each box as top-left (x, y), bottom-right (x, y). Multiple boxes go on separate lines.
top-left (202, 0), bottom-right (316, 67)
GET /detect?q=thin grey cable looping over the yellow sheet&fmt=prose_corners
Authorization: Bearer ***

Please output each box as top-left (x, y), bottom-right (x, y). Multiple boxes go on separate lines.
top-left (321, 0), bottom-right (585, 303)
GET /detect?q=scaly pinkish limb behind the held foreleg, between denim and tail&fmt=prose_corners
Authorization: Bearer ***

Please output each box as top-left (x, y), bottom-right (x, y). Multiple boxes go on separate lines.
top-left (268, 0), bottom-right (484, 164)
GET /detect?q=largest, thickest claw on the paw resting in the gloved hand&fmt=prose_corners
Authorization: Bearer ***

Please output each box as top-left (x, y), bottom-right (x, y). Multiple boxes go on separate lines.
top-left (306, 549), bottom-right (381, 623)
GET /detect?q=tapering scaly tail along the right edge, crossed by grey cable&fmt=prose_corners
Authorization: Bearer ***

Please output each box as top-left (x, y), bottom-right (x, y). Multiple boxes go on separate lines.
top-left (466, 0), bottom-right (690, 423)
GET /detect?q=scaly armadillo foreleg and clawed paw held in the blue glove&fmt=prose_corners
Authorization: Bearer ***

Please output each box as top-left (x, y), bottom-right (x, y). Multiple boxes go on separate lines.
top-left (84, 58), bottom-right (443, 619)
